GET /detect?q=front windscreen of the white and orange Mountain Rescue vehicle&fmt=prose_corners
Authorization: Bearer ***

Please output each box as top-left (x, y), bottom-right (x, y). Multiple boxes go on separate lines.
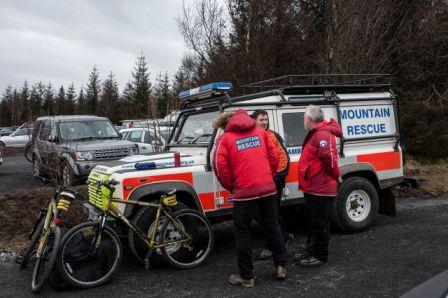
top-left (174, 111), bottom-right (218, 144)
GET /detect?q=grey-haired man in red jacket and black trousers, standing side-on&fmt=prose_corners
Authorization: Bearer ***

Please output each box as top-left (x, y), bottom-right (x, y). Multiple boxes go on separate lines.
top-left (295, 105), bottom-right (342, 267)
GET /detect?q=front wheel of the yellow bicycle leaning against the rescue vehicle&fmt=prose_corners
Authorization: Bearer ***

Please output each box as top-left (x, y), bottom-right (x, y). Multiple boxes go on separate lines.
top-left (56, 222), bottom-right (123, 289)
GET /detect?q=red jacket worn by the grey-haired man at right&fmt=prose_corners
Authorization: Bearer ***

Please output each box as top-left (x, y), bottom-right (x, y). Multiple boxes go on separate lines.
top-left (299, 119), bottom-right (342, 196)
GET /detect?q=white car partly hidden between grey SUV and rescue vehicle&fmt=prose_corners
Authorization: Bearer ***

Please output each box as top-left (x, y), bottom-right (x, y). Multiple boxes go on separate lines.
top-left (120, 127), bottom-right (165, 154)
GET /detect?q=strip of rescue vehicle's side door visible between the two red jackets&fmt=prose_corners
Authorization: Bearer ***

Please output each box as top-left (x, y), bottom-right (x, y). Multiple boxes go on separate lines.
top-left (276, 107), bottom-right (307, 199)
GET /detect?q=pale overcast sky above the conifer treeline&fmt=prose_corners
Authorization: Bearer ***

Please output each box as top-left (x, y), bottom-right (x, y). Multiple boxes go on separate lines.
top-left (0, 0), bottom-right (185, 93)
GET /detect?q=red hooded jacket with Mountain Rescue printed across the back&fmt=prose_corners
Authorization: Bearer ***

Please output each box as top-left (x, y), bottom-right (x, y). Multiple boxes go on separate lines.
top-left (213, 109), bottom-right (278, 201)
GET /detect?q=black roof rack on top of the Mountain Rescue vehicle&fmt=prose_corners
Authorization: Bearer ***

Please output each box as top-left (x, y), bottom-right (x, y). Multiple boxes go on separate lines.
top-left (241, 74), bottom-right (391, 91)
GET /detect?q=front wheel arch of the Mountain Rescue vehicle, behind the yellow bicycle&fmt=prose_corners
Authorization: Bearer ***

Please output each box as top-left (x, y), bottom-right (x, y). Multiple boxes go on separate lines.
top-left (124, 181), bottom-right (202, 217)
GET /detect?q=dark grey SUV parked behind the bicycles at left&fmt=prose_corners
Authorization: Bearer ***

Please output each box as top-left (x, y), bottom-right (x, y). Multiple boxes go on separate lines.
top-left (32, 115), bottom-right (138, 186)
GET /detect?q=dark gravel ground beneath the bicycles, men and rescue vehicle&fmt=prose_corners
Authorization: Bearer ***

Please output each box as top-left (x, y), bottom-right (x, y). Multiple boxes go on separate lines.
top-left (0, 198), bottom-right (448, 297)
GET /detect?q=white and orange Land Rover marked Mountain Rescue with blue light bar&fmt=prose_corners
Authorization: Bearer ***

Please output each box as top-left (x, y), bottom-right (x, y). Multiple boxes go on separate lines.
top-left (85, 75), bottom-right (403, 232)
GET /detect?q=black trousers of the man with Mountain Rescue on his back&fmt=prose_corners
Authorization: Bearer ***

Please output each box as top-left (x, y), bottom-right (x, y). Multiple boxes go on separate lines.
top-left (233, 195), bottom-right (286, 279)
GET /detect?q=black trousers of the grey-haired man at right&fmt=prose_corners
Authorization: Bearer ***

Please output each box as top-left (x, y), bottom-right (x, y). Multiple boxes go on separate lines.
top-left (304, 193), bottom-right (335, 262)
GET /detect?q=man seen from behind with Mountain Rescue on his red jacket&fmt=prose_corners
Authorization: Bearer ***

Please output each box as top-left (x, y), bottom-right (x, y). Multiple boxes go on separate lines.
top-left (213, 109), bottom-right (286, 287)
